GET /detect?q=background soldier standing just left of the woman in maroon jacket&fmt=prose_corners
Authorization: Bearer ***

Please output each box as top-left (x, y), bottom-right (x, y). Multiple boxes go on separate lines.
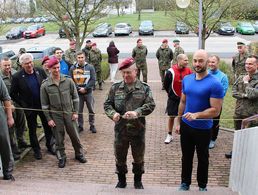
top-left (89, 43), bottom-right (103, 90)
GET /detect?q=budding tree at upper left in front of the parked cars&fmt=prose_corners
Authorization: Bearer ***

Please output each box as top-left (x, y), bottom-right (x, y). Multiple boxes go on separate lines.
top-left (38, 0), bottom-right (108, 49)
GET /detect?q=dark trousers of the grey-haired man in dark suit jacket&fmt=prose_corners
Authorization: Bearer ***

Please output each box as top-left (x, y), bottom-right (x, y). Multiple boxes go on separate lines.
top-left (26, 111), bottom-right (53, 152)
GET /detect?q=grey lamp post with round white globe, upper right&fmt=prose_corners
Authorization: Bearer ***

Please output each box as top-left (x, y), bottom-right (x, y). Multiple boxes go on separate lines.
top-left (176, 0), bottom-right (203, 49)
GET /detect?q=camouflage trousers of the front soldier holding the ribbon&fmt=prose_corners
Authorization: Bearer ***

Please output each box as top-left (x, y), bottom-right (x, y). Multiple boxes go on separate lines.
top-left (114, 121), bottom-right (145, 174)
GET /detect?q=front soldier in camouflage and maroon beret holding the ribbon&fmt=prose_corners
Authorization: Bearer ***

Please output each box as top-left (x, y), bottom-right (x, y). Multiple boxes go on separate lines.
top-left (104, 58), bottom-right (155, 189)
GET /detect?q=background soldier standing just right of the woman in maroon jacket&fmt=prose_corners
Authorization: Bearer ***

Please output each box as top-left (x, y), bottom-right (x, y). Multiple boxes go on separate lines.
top-left (132, 39), bottom-right (148, 83)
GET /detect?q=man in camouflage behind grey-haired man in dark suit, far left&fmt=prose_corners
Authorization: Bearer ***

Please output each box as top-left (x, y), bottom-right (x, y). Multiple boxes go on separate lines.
top-left (0, 57), bottom-right (28, 156)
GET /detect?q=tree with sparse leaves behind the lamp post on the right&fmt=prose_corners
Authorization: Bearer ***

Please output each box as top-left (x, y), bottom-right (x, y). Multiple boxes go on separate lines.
top-left (170, 0), bottom-right (242, 49)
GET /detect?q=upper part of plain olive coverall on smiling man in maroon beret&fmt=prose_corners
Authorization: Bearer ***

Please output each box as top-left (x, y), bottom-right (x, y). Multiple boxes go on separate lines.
top-left (40, 76), bottom-right (79, 121)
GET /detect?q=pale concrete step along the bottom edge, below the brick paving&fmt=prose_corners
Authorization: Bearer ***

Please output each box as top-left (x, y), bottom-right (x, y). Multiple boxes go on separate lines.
top-left (0, 180), bottom-right (238, 195)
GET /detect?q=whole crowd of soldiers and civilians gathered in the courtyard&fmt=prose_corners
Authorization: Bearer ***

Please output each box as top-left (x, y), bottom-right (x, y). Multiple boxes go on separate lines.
top-left (0, 39), bottom-right (258, 191)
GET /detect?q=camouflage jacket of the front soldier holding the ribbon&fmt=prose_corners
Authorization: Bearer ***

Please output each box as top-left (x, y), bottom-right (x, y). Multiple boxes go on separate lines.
top-left (104, 80), bottom-right (155, 133)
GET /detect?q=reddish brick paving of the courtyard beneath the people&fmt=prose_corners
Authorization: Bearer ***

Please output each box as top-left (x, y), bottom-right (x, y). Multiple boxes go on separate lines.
top-left (9, 59), bottom-right (233, 187)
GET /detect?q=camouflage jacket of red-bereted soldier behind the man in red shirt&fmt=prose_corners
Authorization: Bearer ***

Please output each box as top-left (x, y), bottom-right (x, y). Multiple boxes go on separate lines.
top-left (156, 47), bottom-right (173, 70)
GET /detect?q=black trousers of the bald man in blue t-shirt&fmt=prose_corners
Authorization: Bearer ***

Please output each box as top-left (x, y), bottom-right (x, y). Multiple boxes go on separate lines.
top-left (180, 121), bottom-right (210, 188)
